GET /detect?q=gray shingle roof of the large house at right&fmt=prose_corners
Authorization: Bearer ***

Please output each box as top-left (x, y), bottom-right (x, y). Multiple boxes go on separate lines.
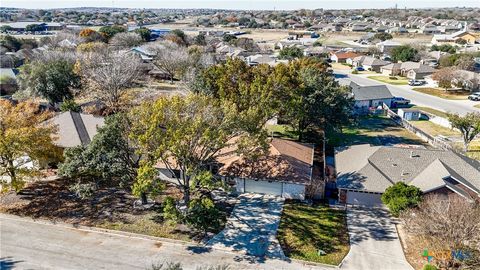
top-left (335, 145), bottom-right (480, 193)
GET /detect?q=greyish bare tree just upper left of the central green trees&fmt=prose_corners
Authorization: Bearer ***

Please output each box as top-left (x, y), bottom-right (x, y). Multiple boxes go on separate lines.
top-left (149, 41), bottom-right (189, 84)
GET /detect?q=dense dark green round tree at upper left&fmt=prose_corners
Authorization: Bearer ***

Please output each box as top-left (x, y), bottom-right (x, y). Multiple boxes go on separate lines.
top-left (18, 56), bottom-right (80, 104)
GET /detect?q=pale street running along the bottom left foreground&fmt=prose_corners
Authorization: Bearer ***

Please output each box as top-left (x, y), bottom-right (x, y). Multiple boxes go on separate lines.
top-left (0, 214), bottom-right (332, 270)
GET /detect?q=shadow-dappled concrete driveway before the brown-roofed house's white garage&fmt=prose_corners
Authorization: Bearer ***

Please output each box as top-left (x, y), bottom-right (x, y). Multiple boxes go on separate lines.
top-left (207, 193), bottom-right (285, 259)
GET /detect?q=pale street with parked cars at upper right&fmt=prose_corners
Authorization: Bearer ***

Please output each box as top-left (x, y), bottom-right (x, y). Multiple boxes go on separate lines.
top-left (334, 70), bottom-right (480, 115)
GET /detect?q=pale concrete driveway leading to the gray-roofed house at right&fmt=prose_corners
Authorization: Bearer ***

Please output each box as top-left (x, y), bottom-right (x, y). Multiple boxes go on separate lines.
top-left (341, 207), bottom-right (413, 270)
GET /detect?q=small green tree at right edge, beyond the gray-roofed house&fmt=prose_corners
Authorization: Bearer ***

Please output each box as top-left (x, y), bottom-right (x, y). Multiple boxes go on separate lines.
top-left (447, 113), bottom-right (480, 153)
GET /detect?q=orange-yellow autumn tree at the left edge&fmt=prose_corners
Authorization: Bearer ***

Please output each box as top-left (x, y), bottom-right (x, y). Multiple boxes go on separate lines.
top-left (0, 100), bottom-right (60, 192)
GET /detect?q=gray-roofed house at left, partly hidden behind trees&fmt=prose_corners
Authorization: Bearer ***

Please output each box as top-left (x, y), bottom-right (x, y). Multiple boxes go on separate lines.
top-left (46, 111), bottom-right (105, 148)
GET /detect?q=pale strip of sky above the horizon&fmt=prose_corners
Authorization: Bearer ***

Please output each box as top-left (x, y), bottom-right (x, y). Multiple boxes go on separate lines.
top-left (0, 0), bottom-right (480, 9)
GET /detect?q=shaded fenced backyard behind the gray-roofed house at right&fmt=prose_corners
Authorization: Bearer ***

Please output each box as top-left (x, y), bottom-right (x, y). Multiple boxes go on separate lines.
top-left (329, 116), bottom-right (424, 146)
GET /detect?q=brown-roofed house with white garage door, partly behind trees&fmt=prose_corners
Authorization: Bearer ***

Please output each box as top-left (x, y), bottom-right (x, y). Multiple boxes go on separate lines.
top-left (156, 138), bottom-right (315, 200)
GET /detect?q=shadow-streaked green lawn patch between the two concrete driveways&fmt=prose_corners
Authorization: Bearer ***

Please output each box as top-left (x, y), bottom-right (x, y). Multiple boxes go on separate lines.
top-left (277, 202), bottom-right (350, 265)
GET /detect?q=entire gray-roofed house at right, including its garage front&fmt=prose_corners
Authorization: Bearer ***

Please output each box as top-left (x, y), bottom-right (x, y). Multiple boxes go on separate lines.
top-left (335, 144), bottom-right (480, 206)
